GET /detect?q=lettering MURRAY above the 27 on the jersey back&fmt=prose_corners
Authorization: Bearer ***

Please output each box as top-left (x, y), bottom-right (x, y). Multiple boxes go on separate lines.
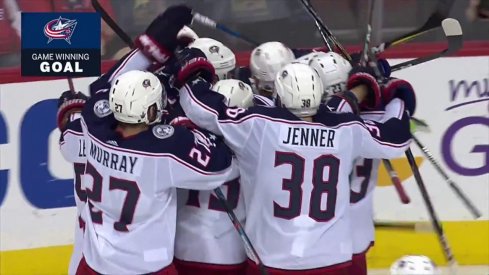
top-left (90, 141), bottom-right (138, 174)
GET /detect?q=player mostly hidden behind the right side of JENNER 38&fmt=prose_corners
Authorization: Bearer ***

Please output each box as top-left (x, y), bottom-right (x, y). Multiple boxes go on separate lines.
top-left (299, 53), bottom-right (415, 275)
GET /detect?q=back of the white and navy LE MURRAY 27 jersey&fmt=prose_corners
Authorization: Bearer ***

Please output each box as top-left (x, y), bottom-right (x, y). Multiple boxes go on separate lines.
top-left (82, 117), bottom-right (236, 274)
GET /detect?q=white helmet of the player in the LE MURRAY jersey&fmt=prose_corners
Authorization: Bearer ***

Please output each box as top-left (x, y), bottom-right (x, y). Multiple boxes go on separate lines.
top-left (109, 70), bottom-right (166, 124)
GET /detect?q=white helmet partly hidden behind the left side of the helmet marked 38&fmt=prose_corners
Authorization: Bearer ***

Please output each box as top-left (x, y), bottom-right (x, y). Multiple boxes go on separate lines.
top-left (250, 42), bottom-right (295, 92)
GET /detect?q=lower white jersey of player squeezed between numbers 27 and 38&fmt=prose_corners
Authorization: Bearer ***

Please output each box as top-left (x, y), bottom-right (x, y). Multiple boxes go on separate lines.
top-left (175, 178), bottom-right (246, 265)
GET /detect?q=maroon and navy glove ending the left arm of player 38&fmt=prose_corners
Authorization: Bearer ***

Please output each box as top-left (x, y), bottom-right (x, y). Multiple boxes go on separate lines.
top-left (174, 48), bottom-right (216, 88)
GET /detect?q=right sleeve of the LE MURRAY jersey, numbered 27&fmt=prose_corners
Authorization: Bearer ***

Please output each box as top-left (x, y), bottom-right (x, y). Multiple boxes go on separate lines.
top-left (165, 127), bottom-right (239, 190)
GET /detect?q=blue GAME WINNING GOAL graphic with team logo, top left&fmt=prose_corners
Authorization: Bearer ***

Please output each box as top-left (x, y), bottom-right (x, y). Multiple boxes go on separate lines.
top-left (21, 12), bottom-right (101, 77)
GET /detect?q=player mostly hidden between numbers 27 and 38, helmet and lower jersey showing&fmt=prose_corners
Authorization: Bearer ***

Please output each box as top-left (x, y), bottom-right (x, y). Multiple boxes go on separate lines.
top-left (174, 79), bottom-right (253, 275)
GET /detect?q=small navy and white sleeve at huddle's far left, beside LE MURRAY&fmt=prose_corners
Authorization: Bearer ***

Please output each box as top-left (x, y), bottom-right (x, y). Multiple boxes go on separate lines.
top-left (59, 118), bottom-right (85, 163)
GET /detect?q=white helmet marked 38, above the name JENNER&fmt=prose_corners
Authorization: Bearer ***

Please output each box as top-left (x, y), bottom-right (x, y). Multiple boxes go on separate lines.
top-left (274, 63), bottom-right (323, 117)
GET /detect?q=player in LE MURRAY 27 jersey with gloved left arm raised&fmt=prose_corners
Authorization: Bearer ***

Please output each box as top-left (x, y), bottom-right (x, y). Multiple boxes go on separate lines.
top-left (59, 6), bottom-right (238, 274)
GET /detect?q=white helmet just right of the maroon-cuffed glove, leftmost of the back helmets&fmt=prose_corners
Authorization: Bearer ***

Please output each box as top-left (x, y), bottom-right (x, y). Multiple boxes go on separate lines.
top-left (188, 38), bottom-right (236, 79)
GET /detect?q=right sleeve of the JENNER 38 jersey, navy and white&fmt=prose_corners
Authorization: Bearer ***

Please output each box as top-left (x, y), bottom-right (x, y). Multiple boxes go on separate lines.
top-left (354, 105), bottom-right (411, 159)
